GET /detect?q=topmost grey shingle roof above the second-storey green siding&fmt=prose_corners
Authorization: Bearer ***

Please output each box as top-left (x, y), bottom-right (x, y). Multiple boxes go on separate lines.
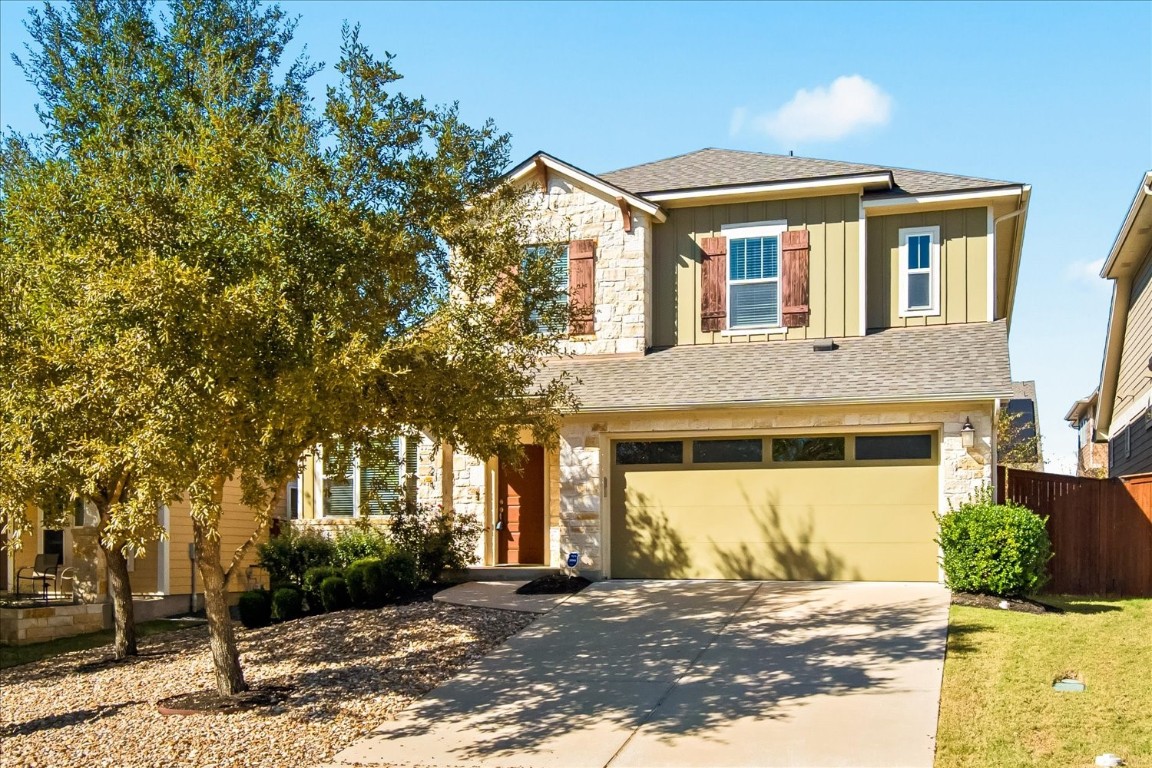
top-left (599, 149), bottom-right (1015, 197)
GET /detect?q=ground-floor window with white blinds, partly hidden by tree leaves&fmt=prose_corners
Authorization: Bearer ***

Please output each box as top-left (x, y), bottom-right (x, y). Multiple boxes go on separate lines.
top-left (321, 435), bottom-right (419, 517)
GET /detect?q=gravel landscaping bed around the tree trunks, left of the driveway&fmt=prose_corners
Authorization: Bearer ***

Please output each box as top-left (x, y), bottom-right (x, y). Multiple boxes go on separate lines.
top-left (0, 602), bottom-right (532, 768)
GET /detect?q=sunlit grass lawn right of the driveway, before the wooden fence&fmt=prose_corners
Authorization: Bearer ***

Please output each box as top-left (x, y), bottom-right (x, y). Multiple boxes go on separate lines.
top-left (935, 598), bottom-right (1152, 768)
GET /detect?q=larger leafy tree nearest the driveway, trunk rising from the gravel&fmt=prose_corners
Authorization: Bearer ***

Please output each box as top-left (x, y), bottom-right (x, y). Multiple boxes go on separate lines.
top-left (0, 0), bottom-right (571, 694)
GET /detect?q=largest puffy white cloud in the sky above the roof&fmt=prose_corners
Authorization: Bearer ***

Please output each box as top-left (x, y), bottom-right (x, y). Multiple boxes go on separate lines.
top-left (729, 75), bottom-right (892, 143)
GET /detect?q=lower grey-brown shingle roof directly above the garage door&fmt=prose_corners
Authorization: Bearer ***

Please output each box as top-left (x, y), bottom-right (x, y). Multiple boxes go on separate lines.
top-left (539, 320), bottom-right (1013, 411)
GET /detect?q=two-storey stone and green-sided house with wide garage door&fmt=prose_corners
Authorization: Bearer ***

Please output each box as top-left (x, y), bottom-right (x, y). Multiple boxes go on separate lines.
top-left (297, 150), bottom-right (1030, 581)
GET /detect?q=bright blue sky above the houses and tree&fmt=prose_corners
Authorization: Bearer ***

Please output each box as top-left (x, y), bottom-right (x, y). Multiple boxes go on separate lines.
top-left (0, 0), bottom-right (1152, 456)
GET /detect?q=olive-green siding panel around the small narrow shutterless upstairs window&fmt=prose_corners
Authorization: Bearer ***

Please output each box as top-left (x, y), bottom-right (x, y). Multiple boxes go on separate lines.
top-left (867, 207), bottom-right (988, 329)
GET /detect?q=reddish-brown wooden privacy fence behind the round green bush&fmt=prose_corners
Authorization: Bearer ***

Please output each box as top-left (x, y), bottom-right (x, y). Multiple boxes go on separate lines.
top-left (996, 466), bottom-right (1152, 598)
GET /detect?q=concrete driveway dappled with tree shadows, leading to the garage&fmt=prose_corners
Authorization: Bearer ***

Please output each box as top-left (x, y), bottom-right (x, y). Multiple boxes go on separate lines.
top-left (322, 581), bottom-right (948, 768)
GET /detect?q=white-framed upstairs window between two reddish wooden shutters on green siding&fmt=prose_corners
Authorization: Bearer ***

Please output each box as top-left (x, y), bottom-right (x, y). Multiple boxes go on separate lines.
top-left (723, 223), bottom-right (786, 328)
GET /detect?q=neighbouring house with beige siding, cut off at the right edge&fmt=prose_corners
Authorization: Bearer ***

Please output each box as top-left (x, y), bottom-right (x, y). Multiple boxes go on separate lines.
top-left (1096, 172), bottom-right (1152, 477)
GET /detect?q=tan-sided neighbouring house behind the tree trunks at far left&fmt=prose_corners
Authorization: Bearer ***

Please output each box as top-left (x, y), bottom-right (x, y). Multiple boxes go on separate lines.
top-left (0, 481), bottom-right (267, 619)
